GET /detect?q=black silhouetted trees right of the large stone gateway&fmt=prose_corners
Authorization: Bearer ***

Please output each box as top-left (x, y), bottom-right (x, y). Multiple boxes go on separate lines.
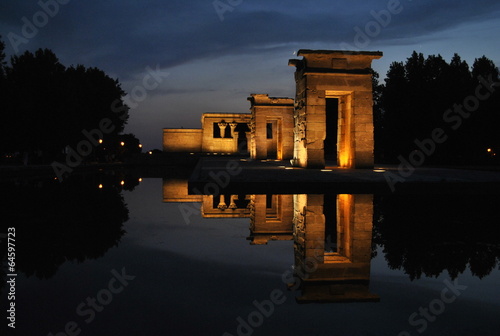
top-left (374, 52), bottom-right (500, 164)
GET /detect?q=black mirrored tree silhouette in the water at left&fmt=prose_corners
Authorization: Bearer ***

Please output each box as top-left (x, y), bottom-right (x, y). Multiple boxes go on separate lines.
top-left (0, 172), bottom-right (135, 284)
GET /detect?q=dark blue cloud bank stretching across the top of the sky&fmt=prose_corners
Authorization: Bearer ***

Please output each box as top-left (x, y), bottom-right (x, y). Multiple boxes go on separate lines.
top-left (1, 0), bottom-right (500, 76)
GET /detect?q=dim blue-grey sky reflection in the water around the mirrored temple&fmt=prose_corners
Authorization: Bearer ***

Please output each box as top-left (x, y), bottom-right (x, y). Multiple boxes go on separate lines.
top-left (2, 179), bottom-right (500, 336)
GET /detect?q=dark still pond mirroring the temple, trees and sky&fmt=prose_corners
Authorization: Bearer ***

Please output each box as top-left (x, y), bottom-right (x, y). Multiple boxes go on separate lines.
top-left (0, 171), bottom-right (500, 336)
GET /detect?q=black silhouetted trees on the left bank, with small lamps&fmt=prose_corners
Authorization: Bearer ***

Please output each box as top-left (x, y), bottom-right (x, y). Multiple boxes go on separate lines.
top-left (0, 37), bottom-right (140, 164)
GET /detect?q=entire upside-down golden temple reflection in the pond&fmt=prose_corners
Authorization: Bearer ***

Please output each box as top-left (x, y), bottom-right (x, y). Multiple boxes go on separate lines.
top-left (163, 179), bottom-right (380, 303)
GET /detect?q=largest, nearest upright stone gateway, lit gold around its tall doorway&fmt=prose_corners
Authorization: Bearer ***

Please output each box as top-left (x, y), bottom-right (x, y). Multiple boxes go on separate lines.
top-left (289, 50), bottom-right (383, 168)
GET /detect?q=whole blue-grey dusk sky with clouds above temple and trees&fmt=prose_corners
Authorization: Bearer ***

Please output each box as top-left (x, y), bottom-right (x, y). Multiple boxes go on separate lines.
top-left (0, 0), bottom-right (500, 149)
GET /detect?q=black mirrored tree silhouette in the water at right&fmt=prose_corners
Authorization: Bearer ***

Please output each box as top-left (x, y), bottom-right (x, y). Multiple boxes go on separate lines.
top-left (373, 195), bottom-right (500, 280)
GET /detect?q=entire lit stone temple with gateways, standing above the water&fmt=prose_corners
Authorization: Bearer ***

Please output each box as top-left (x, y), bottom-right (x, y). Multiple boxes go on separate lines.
top-left (163, 49), bottom-right (382, 168)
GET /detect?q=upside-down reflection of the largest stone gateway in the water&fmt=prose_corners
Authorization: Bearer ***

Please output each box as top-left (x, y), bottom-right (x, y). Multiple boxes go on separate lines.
top-left (294, 195), bottom-right (380, 303)
